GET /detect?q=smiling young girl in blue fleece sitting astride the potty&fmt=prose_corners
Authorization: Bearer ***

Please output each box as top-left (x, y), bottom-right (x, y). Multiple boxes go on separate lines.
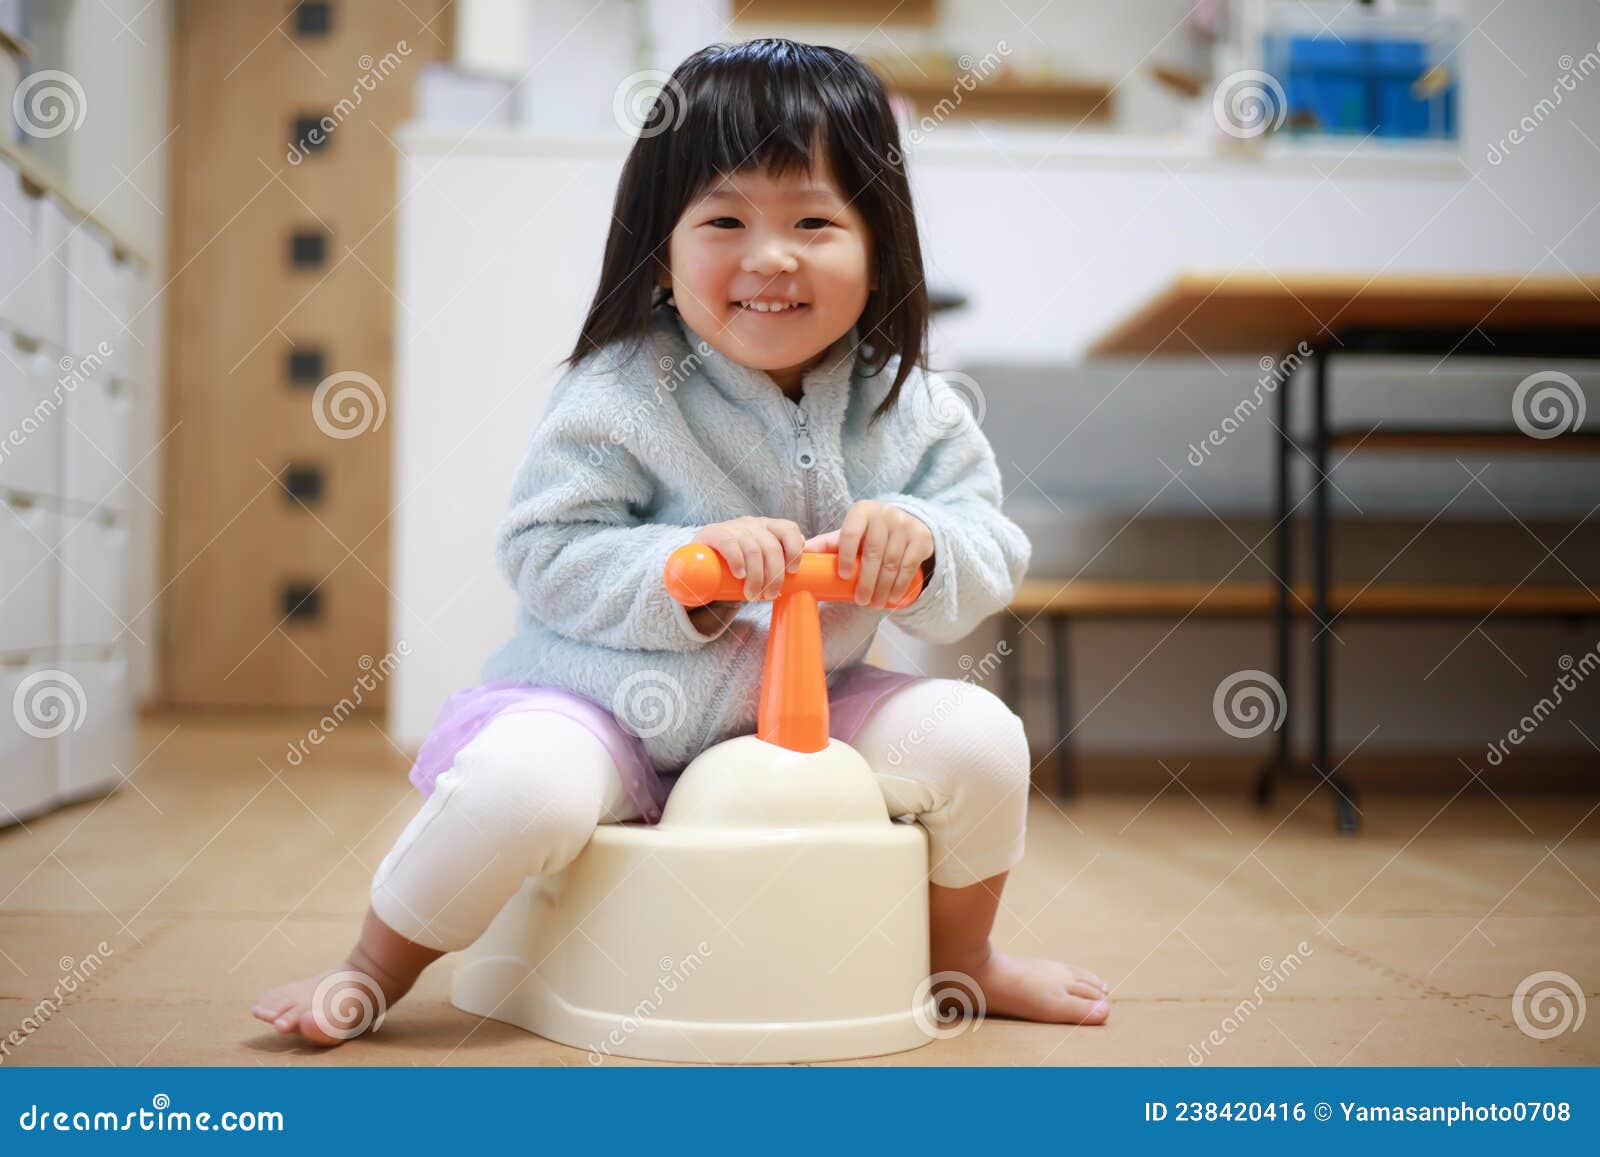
top-left (253, 40), bottom-right (1109, 1045)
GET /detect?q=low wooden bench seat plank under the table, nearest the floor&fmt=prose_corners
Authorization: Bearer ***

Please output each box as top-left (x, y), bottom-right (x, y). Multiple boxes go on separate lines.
top-left (1011, 578), bottom-right (1600, 619)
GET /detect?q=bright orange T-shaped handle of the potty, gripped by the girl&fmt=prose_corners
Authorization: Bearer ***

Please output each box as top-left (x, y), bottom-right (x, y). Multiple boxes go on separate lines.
top-left (664, 542), bottom-right (922, 752)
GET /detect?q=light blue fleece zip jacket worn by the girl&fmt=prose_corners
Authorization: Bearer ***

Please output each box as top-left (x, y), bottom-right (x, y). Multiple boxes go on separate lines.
top-left (482, 306), bottom-right (1030, 771)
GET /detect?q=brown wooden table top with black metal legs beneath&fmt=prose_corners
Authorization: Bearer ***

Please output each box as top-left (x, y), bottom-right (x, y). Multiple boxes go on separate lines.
top-left (1090, 270), bottom-right (1600, 357)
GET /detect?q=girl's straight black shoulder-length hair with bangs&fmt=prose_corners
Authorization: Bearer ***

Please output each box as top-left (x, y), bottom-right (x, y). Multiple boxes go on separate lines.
top-left (566, 38), bottom-right (928, 419)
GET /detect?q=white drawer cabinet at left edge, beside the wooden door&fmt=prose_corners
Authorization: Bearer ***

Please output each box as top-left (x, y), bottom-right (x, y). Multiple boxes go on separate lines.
top-left (0, 149), bottom-right (147, 827)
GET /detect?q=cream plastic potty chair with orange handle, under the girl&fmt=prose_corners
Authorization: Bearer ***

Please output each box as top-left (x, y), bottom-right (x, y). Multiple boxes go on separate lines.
top-left (451, 546), bottom-right (938, 1063)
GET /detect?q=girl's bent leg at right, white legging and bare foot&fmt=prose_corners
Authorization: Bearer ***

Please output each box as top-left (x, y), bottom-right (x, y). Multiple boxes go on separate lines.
top-left (853, 679), bottom-right (1109, 1024)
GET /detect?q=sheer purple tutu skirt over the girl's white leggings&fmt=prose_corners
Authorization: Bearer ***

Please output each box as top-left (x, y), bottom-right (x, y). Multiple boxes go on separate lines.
top-left (410, 663), bottom-right (923, 824)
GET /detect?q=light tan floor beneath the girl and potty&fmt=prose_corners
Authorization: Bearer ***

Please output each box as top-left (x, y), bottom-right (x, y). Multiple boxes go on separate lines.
top-left (0, 717), bottom-right (1600, 1066)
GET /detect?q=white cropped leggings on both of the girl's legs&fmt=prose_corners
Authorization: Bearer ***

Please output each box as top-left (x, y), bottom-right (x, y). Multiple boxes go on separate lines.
top-left (371, 679), bottom-right (1029, 952)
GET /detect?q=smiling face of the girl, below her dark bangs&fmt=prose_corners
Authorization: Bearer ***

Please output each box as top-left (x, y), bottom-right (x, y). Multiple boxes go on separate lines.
top-left (662, 149), bottom-right (877, 395)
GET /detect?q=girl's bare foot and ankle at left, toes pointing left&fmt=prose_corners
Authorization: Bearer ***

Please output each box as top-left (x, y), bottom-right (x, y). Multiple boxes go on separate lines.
top-left (250, 909), bottom-right (443, 1045)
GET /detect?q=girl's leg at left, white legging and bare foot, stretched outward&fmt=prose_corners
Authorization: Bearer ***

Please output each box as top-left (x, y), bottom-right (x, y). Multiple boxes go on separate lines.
top-left (251, 712), bottom-right (638, 1045)
